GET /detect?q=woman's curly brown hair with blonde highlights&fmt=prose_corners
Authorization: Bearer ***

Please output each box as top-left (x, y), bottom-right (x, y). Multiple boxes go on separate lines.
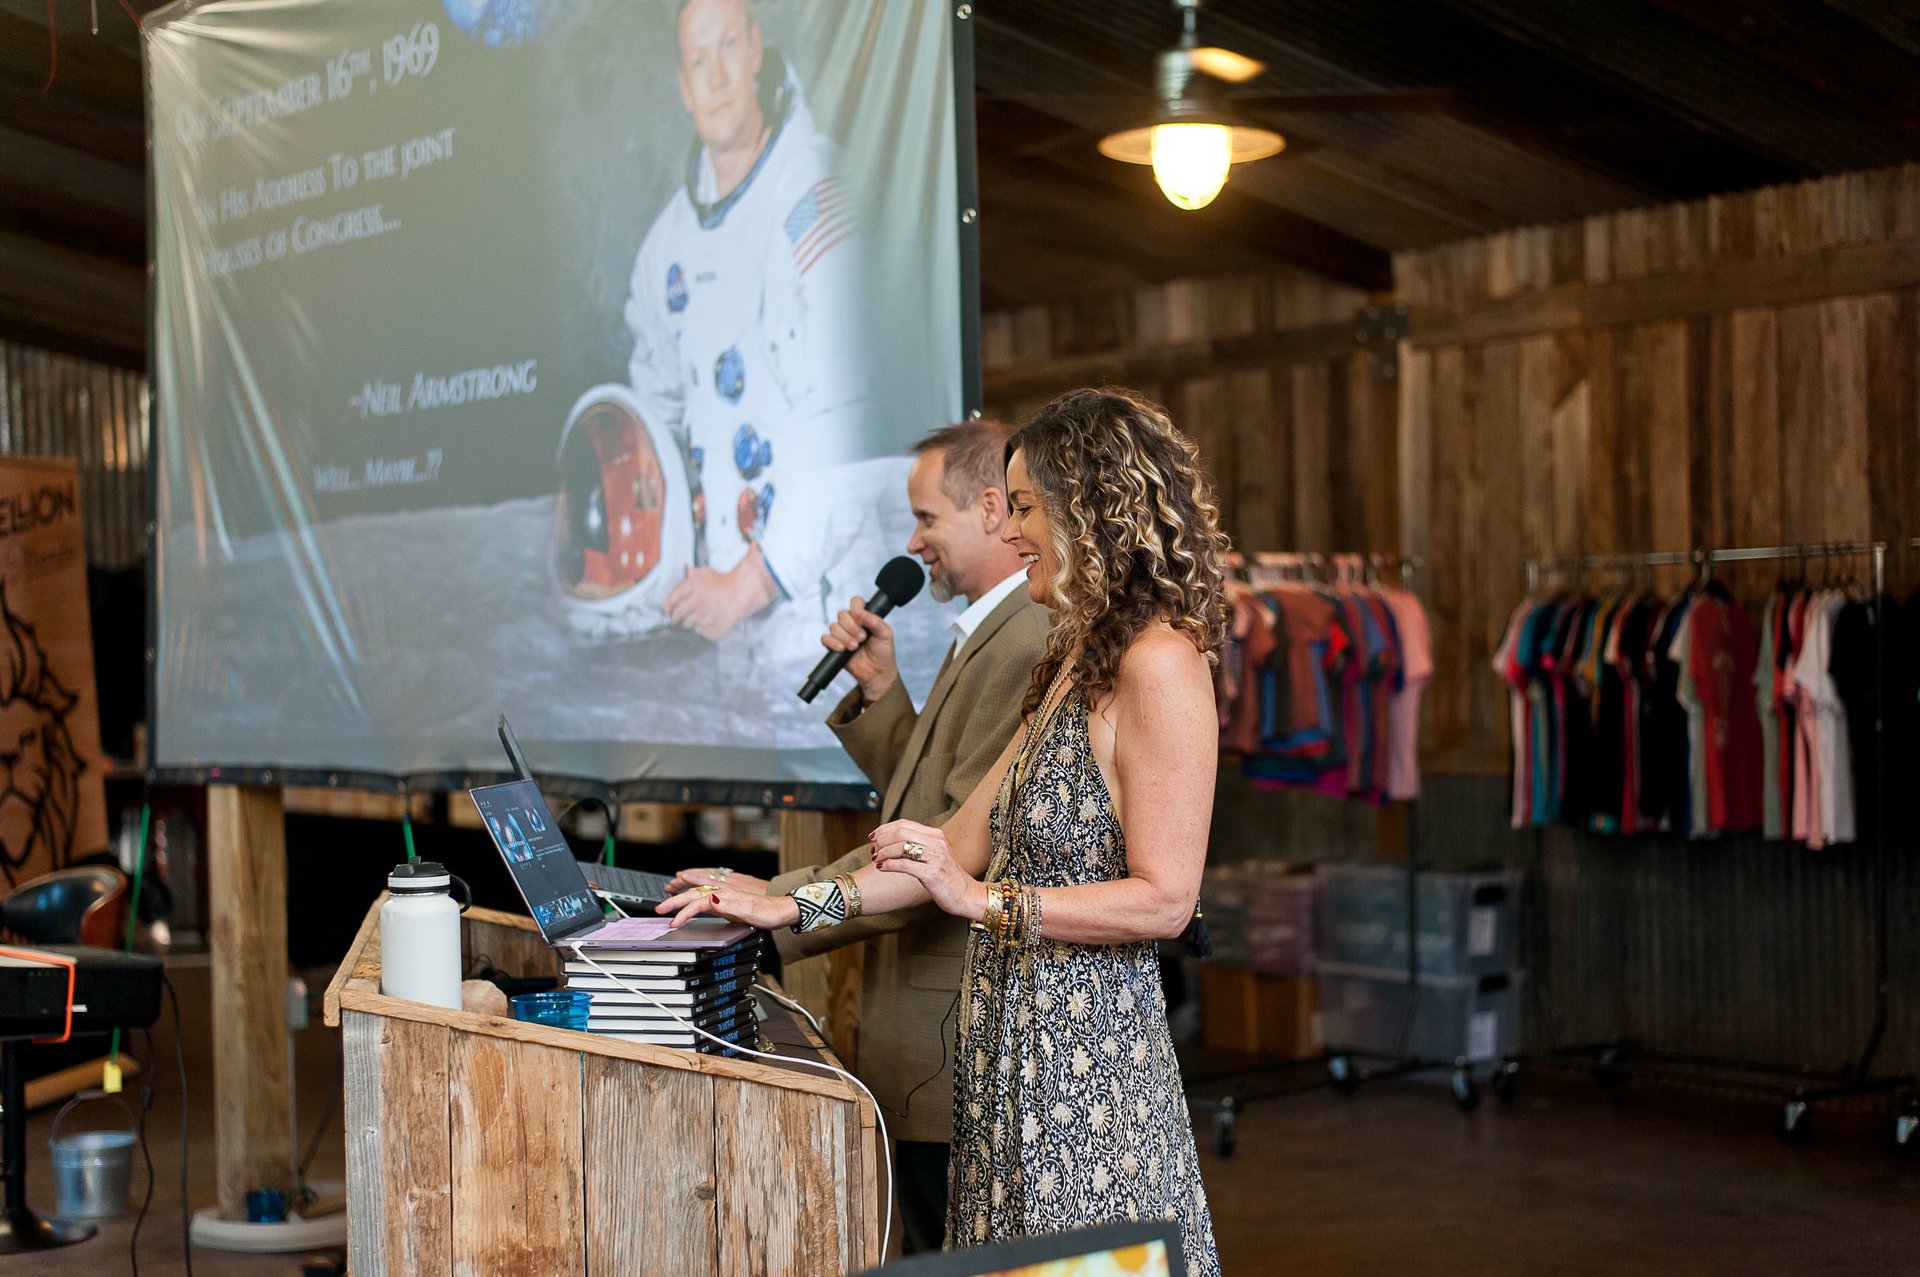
top-left (1006, 388), bottom-right (1227, 714)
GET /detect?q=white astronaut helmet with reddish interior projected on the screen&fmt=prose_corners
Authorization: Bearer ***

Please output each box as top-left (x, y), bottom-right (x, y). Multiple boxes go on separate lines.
top-left (551, 384), bottom-right (693, 639)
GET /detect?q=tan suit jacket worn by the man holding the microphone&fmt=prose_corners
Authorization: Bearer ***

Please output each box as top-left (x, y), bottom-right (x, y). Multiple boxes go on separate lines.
top-left (770, 588), bottom-right (1048, 1143)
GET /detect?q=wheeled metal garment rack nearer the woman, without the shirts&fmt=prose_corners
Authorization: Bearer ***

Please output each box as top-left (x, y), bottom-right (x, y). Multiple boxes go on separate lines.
top-left (1187, 553), bottom-right (1480, 1158)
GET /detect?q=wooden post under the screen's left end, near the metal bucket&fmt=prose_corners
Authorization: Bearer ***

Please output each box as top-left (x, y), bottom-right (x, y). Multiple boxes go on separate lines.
top-left (207, 785), bottom-right (294, 1219)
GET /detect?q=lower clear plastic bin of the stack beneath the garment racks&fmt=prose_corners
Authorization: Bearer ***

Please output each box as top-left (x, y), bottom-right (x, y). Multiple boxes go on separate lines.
top-left (1317, 960), bottom-right (1526, 1064)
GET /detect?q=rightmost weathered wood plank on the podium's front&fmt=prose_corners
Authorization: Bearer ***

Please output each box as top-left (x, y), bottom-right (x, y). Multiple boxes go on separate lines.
top-left (714, 1079), bottom-right (868, 1273)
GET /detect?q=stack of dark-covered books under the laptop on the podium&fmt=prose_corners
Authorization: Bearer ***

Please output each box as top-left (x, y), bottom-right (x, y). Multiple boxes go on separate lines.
top-left (566, 918), bottom-right (766, 1054)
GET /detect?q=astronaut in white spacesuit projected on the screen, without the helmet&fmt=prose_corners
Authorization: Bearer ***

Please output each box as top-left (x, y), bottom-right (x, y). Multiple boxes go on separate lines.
top-left (626, 0), bottom-right (874, 641)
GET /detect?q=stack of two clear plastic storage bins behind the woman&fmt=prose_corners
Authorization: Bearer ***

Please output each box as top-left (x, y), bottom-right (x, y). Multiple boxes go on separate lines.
top-left (1315, 864), bottom-right (1526, 1066)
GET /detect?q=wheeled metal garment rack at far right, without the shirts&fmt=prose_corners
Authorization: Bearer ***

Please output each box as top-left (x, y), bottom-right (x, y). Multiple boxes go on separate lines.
top-left (1494, 538), bottom-right (1920, 1150)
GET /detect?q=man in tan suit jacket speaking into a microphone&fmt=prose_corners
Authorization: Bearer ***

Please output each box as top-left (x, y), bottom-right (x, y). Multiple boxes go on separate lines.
top-left (674, 421), bottom-right (1048, 1252)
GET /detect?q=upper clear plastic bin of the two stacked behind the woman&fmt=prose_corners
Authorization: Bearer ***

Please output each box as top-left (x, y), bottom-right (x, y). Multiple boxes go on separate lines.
top-left (1315, 864), bottom-right (1521, 976)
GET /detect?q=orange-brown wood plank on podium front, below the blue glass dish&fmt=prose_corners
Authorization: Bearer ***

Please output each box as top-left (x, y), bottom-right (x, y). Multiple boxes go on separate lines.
top-left (449, 1033), bottom-right (586, 1277)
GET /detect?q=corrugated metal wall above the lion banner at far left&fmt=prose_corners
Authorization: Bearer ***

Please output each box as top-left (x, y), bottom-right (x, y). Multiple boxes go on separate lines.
top-left (0, 342), bottom-right (146, 568)
